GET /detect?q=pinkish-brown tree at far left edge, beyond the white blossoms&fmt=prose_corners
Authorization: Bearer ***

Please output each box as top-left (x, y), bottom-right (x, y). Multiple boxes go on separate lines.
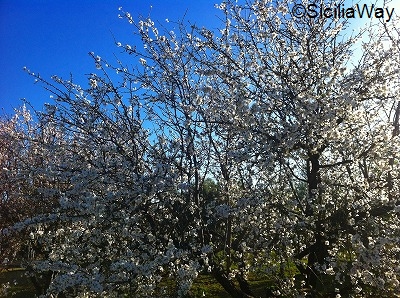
top-left (0, 105), bottom-right (72, 295)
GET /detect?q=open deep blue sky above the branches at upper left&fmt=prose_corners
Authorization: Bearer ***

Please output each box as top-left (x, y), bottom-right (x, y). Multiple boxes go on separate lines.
top-left (0, 0), bottom-right (218, 115)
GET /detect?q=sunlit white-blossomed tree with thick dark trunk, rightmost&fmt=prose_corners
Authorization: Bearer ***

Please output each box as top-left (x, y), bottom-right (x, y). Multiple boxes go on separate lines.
top-left (190, 1), bottom-right (399, 295)
